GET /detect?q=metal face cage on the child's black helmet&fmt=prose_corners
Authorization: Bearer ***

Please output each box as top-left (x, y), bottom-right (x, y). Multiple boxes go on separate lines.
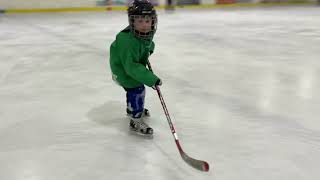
top-left (129, 14), bottom-right (158, 40)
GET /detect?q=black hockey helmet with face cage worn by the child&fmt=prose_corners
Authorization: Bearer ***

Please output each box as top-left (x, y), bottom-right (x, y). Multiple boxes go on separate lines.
top-left (128, 0), bottom-right (158, 40)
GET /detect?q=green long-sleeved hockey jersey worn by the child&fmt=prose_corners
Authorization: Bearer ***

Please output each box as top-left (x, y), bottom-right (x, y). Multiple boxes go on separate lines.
top-left (110, 28), bottom-right (159, 88)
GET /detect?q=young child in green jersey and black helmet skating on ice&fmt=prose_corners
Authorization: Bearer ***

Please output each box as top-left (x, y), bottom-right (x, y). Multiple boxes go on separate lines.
top-left (110, 0), bottom-right (162, 135)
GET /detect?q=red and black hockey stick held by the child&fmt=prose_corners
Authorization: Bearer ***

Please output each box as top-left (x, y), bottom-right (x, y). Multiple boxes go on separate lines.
top-left (147, 61), bottom-right (209, 171)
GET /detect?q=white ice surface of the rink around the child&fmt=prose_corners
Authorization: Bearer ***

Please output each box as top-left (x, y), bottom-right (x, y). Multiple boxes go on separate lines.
top-left (0, 4), bottom-right (320, 180)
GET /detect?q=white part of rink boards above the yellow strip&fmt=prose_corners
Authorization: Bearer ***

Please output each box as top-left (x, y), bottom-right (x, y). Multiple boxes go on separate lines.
top-left (0, 0), bottom-right (317, 10)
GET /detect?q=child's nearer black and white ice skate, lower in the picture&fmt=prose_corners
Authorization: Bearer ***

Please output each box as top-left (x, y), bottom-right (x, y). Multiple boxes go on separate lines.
top-left (130, 117), bottom-right (153, 136)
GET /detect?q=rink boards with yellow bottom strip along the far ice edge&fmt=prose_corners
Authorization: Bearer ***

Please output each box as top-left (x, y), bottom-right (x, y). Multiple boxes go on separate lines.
top-left (0, 0), bottom-right (317, 14)
